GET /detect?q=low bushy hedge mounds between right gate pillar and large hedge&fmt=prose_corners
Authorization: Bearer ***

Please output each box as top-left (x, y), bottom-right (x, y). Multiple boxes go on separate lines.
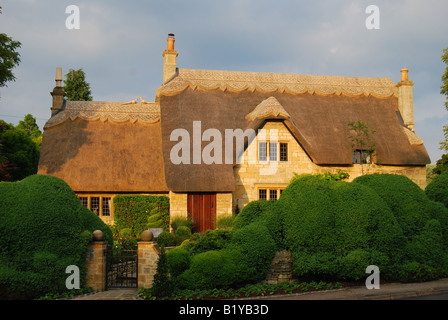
top-left (167, 223), bottom-right (277, 289)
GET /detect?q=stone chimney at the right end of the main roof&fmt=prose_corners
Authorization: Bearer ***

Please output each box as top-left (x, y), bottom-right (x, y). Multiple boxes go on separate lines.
top-left (397, 69), bottom-right (415, 131)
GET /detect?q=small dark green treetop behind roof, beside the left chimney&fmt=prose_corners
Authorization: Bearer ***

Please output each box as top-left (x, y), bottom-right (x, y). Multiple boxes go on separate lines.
top-left (64, 69), bottom-right (92, 101)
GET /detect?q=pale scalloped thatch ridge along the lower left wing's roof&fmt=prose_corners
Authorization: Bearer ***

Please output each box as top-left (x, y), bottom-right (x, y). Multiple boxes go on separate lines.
top-left (44, 101), bottom-right (160, 129)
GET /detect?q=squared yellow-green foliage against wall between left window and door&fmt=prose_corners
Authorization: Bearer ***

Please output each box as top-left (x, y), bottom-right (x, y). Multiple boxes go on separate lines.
top-left (114, 195), bottom-right (170, 239)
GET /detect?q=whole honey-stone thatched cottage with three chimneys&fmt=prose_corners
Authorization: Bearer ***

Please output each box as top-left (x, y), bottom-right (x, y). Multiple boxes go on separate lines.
top-left (38, 34), bottom-right (430, 231)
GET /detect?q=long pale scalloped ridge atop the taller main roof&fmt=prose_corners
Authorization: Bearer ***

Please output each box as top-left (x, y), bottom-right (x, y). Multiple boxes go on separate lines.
top-left (158, 69), bottom-right (398, 98)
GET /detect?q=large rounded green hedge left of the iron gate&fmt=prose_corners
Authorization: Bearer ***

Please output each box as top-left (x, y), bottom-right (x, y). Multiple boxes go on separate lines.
top-left (0, 175), bottom-right (112, 299)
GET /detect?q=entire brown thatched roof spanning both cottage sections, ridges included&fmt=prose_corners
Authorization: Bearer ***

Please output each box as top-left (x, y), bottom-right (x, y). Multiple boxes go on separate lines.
top-left (39, 69), bottom-right (430, 193)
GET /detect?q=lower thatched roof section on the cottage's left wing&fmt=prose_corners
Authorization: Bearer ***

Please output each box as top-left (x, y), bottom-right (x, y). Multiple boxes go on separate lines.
top-left (38, 101), bottom-right (168, 193)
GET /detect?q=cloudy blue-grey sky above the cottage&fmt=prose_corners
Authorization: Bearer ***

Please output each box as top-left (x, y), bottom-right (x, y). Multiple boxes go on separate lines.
top-left (0, 0), bottom-right (448, 163)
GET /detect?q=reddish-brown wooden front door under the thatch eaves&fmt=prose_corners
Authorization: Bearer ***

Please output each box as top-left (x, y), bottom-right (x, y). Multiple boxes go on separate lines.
top-left (187, 193), bottom-right (216, 232)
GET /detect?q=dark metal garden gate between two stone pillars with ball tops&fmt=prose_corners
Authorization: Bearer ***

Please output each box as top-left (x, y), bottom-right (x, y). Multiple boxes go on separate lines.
top-left (106, 250), bottom-right (138, 289)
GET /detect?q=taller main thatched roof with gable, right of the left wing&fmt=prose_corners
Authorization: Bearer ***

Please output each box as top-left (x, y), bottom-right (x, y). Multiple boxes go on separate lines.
top-left (158, 69), bottom-right (430, 192)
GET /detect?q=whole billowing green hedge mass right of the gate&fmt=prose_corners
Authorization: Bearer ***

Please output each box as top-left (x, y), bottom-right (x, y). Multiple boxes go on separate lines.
top-left (155, 174), bottom-right (448, 296)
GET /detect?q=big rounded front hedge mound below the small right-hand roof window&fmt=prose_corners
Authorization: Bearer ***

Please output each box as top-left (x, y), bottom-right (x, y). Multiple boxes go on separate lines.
top-left (278, 176), bottom-right (405, 280)
